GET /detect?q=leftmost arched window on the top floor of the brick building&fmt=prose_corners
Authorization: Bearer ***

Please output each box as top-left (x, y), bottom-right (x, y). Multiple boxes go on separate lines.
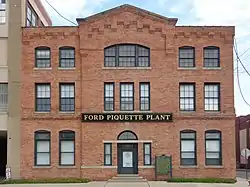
top-left (35, 47), bottom-right (51, 68)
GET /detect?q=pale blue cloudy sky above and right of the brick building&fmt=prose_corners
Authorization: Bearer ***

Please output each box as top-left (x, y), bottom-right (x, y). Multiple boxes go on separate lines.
top-left (42, 0), bottom-right (250, 116)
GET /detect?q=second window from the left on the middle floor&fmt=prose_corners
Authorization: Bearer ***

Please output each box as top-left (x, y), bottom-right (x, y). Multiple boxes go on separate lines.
top-left (60, 83), bottom-right (75, 112)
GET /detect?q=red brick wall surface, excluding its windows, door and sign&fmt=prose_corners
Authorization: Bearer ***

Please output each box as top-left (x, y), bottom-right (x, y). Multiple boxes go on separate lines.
top-left (21, 6), bottom-right (236, 180)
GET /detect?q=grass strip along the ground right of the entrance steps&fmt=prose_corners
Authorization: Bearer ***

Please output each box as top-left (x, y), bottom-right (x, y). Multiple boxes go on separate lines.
top-left (167, 178), bottom-right (237, 184)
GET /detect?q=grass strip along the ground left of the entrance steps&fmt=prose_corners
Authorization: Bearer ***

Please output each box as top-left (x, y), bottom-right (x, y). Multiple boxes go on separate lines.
top-left (0, 178), bottom-right (90, 184)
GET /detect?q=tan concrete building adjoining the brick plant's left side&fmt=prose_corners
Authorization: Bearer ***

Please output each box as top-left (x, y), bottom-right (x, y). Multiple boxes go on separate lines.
top-left (0, 0), bottom-right (51, 178)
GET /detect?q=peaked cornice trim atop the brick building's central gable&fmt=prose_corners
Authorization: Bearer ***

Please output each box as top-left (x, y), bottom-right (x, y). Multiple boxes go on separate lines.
top-left (76, 4), bottom-right (178, 24)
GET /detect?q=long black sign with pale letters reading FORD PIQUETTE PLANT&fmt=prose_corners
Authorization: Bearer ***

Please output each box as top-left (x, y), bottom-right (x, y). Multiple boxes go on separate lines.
top-left (82, 113), bottom-right (173, 122)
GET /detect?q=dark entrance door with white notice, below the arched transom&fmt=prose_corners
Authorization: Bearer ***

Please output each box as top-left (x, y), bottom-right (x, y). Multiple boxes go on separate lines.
top-left (117, 143), bottom-right (138, 174)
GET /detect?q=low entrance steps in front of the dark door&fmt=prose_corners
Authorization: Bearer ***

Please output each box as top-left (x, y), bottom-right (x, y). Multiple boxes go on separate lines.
top-left (108, 174), bottom-right (147, 182)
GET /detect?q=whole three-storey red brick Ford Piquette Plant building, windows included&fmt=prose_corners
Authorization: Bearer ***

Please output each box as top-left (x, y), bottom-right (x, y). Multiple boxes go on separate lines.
top-left (21, 5), bottom-right (236, 180)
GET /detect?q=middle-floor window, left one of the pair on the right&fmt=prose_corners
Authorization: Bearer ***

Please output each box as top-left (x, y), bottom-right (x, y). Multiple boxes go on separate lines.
top-left (180, 83), bottom-right (195, 111)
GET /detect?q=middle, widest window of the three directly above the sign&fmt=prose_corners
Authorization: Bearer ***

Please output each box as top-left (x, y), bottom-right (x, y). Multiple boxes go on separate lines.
top-left (120, 83), bottom-right (134, 111)
